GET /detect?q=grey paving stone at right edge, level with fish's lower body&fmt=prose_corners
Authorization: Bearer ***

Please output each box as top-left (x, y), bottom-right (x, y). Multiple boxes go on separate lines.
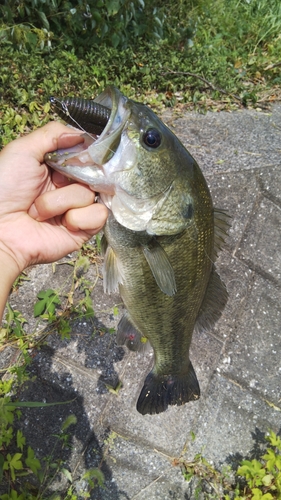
top-left (219, 276), bottom-right (281, 404)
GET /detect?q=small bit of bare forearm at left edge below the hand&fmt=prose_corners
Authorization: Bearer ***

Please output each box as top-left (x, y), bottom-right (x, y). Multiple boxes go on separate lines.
top-left (0, 250), bottom-right (19, 324)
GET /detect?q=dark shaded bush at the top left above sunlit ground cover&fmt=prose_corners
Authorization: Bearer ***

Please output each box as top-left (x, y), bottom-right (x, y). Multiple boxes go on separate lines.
top-left (0, 0), bottom-right (164, 53)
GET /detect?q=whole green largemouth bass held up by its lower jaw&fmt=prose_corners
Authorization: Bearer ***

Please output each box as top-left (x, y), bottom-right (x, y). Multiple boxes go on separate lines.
top-left (45, 86), bottom-right (229, 415)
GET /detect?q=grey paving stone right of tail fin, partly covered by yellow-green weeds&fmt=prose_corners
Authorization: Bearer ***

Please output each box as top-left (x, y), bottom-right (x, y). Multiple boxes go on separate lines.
top-left (182, 373), bottom-right (280, 468)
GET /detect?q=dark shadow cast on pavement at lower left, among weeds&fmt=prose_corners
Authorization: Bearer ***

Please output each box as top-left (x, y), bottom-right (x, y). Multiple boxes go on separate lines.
top-left (3, 314), bottom-right (129, 500)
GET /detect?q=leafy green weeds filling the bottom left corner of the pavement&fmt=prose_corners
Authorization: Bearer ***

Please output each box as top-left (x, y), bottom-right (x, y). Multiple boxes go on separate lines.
top-left (0, 400), bottom-right (104, 500)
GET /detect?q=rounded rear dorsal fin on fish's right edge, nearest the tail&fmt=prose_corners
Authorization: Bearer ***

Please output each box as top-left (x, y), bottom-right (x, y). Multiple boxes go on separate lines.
top-left (195, 266), bottom-right (228, 331)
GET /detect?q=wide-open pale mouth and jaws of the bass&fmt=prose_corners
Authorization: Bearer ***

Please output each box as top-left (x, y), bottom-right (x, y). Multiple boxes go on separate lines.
top-left (44, 86), bottom-right (130, 194)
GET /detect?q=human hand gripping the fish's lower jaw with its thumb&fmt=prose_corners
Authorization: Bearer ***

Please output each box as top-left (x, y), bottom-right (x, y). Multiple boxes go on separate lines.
top-left (0, 122), bottom-right (107, 279)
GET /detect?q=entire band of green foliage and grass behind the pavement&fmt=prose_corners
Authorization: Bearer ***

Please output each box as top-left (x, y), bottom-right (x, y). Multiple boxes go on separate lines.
top-left (0, 0), bottom-right (281, 146)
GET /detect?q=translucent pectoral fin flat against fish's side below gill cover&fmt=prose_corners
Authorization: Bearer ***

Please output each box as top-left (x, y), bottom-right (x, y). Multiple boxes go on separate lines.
top-left (143, 240), bottom-right (177, 296)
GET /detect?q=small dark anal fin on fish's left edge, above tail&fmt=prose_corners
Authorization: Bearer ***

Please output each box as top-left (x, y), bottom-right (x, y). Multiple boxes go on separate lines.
top-left (117, 311), bottom-right (150, 351)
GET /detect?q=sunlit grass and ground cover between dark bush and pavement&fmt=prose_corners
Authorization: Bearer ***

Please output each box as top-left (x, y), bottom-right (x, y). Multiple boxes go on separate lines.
top-left (0, 0), bottom-right (281, 145)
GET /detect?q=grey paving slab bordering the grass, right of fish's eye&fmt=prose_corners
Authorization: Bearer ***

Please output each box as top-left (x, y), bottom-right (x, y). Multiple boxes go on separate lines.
top-left (163, 106), bottom-right (281, 174)
